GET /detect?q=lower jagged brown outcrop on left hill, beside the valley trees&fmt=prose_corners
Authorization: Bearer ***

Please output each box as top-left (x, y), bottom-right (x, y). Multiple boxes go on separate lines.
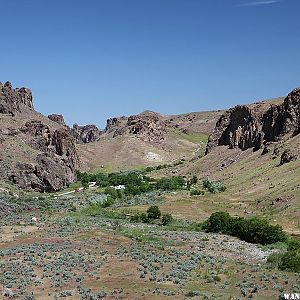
top-left (9, 121), bottom-right (79, 192)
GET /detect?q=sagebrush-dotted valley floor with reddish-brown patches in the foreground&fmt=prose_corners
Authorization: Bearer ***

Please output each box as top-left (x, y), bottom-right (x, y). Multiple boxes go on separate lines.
top-left (0, 186), bottom-right (300, 299)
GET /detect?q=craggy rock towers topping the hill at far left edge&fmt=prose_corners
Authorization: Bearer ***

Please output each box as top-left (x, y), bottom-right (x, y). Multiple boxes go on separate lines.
top-left (0, 81), bottom-right (33, 116)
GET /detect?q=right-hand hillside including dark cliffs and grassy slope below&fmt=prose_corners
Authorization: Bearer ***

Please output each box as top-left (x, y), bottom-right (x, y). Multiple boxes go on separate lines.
top-left (158, 89), bottom-right (300, 234)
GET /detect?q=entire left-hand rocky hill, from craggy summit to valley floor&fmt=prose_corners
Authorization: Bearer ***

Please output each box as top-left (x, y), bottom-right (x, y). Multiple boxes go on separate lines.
top-left (0, 83), bottom-right (79, 192)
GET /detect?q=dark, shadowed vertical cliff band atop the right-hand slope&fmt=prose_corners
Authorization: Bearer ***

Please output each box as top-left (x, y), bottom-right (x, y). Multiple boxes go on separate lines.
top-left (206, 88), bottom-right (300, 154)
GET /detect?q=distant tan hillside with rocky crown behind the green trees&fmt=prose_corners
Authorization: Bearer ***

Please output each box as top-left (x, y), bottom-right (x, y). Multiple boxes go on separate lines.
top-left (77, 112), bottom-right (221, 171)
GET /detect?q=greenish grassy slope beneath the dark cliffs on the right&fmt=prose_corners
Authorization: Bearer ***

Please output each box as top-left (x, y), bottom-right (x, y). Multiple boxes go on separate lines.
top-left (150, 136), bottom-right (300, 234)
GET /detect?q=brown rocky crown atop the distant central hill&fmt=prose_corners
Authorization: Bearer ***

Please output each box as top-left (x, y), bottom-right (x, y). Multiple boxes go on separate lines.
top-left (105, 114), bottom-right (167, 142)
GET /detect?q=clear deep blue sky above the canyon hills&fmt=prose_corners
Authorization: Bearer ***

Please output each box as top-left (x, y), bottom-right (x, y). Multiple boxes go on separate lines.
top-left (0, 0), bottom-right (300, 127)
